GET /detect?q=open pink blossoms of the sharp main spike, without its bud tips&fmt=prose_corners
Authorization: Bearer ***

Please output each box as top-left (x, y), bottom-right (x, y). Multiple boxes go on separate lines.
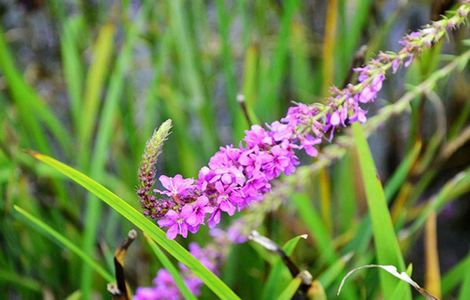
top-left (152, 81), bottom-right (385, 239)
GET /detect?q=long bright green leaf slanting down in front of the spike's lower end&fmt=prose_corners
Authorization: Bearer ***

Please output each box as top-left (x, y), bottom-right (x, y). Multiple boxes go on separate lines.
top-left (32, 153), bottom-right (239, 299)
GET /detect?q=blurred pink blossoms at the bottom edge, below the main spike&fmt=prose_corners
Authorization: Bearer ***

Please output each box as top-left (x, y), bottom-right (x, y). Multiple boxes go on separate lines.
top-left (134, 243), bottom-right (221, 300)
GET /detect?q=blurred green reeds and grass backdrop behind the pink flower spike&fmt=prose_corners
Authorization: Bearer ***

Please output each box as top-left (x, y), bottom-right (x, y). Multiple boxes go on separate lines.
top-left (0, 0), bottom-right (470, 299)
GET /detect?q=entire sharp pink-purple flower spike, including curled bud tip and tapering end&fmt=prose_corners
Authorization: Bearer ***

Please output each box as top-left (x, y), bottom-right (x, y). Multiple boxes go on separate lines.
top-left (137, 0), bottom-right (470, 239)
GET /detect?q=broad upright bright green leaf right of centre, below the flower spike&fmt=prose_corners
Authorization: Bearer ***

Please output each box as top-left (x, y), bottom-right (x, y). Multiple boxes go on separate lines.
top-left (352, 123), bottom-right (411, 299)
